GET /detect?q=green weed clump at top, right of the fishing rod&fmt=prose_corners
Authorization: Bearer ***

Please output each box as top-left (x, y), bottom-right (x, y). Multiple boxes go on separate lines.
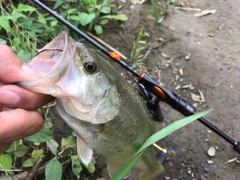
top-left (54, 0), bottom-right (127, 35)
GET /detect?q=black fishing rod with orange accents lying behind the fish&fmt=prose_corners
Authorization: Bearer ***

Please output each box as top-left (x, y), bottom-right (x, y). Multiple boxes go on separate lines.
top-left (29, 0), bottom-right (240, 154)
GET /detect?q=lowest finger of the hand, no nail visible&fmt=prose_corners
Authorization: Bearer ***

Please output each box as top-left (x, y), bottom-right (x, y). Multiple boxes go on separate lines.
top-left (0, 109), bottom-right (43, 144)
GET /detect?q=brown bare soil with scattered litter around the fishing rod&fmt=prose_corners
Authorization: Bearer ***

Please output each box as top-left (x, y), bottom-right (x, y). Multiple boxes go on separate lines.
top-left (51, 0), bottom-right (240, 180)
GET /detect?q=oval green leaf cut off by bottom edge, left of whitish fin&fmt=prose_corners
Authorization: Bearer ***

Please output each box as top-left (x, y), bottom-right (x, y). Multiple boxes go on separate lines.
top-left (45, 159), bottom-right (62, 180)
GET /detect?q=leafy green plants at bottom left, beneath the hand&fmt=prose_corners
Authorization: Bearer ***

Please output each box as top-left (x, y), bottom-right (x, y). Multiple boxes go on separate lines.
top-left (0, 109), bottom-right (87, 180)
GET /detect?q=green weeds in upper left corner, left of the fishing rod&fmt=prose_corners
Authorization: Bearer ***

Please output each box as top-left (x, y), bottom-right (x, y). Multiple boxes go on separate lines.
top-left (0, 1), bottom-right (67, 62)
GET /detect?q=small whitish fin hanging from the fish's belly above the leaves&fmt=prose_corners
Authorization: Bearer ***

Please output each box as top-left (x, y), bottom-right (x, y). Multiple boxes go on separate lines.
top-left (77, 136), bottom-right (93, 165)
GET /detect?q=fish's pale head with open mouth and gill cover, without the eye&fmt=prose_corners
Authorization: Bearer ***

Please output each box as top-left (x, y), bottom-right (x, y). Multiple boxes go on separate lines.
top-left (19, 33), bottom-right (120, 124)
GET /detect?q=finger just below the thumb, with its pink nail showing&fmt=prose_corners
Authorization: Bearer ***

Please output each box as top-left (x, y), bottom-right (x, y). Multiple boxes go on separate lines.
top-left (0, 85), bottom-right (53, 110)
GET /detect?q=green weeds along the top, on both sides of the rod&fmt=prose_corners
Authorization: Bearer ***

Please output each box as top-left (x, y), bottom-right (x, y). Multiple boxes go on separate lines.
top-left (0, 0), bottom-right (127, 62)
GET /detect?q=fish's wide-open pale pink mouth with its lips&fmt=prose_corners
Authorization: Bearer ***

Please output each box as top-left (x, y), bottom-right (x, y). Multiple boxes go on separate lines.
top-left (18, 32), bottom-right (75, 92)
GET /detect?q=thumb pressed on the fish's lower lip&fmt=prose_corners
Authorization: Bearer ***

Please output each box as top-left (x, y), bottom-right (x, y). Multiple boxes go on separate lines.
top-left (0, 44), bottom-right (38, 83)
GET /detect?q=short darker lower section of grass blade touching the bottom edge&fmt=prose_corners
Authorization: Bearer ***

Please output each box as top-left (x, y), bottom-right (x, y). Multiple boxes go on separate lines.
top-left (110, 151), bottom-right (144, 180)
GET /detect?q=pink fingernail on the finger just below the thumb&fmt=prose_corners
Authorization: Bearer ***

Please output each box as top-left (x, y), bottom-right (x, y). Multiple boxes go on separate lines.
top-left (0, 90), bottom-right (20, 105)
